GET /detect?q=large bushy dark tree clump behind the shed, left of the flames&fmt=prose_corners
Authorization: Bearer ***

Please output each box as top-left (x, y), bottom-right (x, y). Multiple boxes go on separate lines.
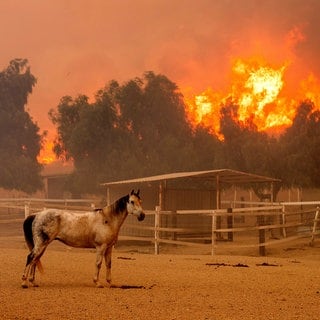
top-left (49, 72), bottom-right (220, 192)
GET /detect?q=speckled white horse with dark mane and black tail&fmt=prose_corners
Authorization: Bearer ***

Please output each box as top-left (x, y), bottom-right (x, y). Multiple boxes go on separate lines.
top-left (22, 190), bottom-right (145, 288)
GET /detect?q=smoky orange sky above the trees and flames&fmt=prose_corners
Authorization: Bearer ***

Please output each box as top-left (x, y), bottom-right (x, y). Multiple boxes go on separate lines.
top-left (0, 0), bottom-right (320, 146)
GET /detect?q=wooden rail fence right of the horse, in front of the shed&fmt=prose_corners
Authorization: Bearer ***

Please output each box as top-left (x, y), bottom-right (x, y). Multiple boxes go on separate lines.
top-left (120, 203), bottom-right (320, 255)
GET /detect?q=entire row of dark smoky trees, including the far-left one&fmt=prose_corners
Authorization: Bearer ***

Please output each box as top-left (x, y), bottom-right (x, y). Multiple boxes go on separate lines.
top-left (0, 60), bottom-right (320, 193)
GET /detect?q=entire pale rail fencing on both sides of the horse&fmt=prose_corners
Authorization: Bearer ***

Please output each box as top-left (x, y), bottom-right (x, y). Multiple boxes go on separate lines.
top-left (0, 199), bottom-right (320, 256)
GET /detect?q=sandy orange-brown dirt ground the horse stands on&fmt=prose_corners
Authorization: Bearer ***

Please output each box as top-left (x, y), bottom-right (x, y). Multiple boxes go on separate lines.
top-left (0, 221), bottom-right (320, 320)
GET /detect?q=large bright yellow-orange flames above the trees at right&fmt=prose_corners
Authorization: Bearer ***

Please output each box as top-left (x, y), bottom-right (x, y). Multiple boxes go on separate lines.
top-left (184, 59), bottom-right (320, 136)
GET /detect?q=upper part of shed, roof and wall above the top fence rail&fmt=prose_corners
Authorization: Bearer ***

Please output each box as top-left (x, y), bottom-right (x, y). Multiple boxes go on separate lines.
top-left (102, 169), bottom-right (280, 210)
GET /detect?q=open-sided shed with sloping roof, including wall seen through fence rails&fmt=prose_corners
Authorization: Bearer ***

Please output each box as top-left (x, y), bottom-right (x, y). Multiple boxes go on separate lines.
top-left (102, 169), bottom-right (280, 246)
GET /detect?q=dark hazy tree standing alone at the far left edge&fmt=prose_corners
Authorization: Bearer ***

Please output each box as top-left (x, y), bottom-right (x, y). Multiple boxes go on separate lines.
top-left (0, 59), bottom-right (42, 193)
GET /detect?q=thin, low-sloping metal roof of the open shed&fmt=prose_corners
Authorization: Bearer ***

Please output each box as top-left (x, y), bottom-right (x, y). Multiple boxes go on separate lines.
top-left (101, 169), bottom-right (281, 186)
